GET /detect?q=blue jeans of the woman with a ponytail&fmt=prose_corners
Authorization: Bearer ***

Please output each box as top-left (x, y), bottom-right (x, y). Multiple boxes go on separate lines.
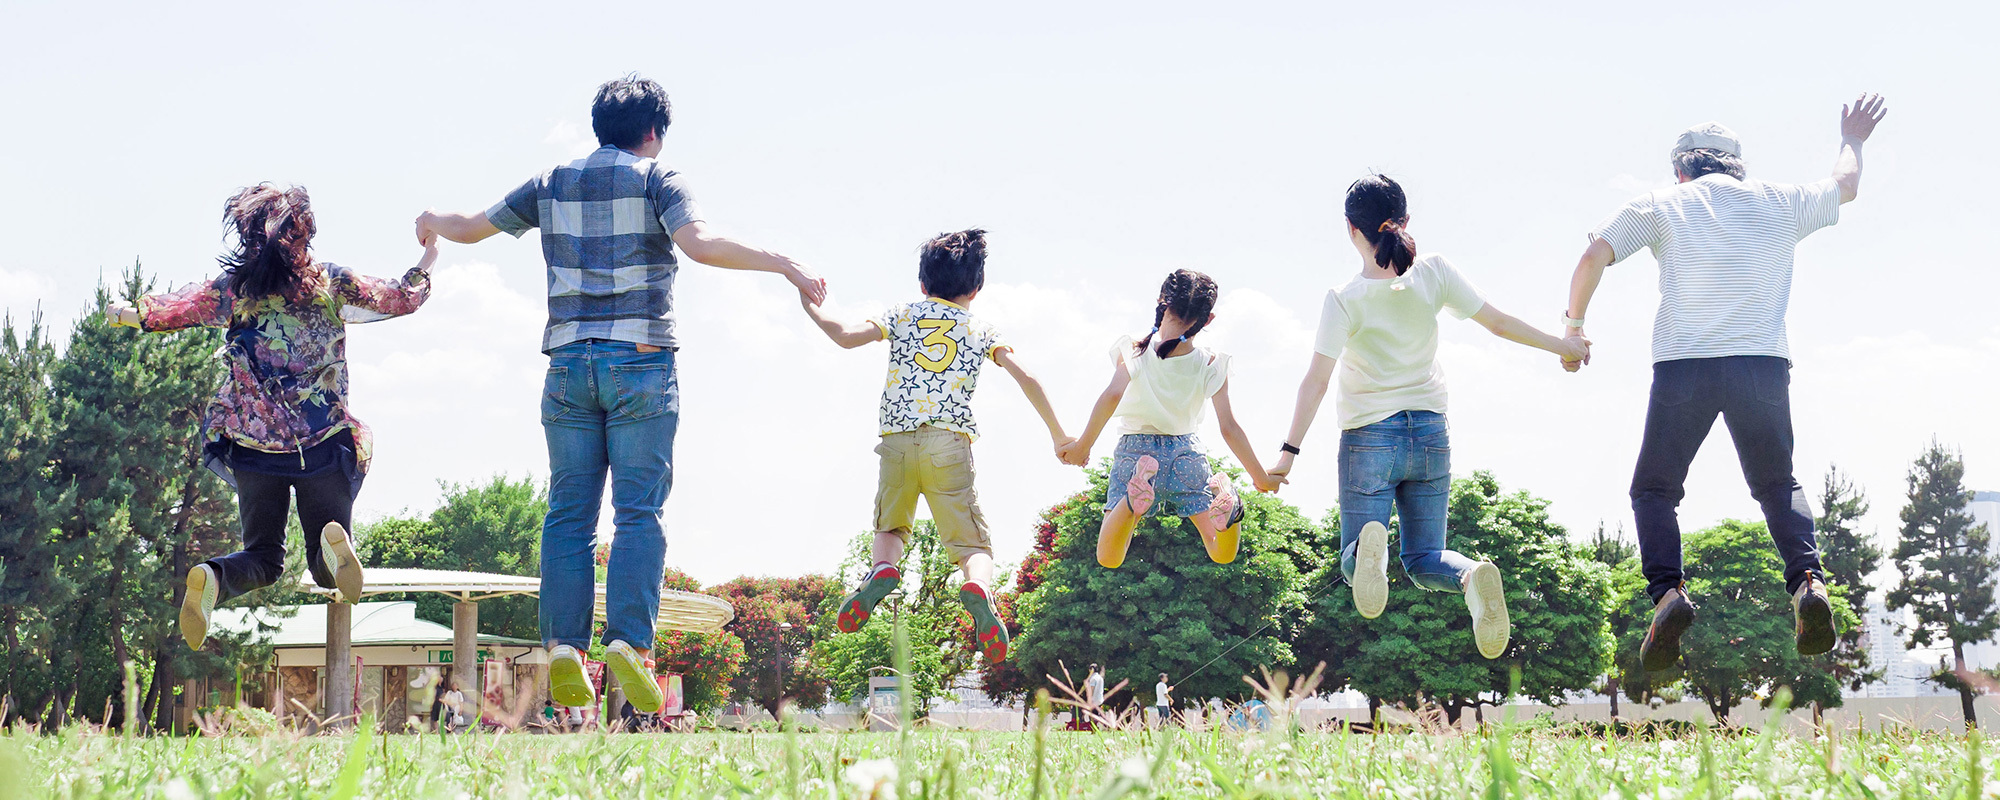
top-left (1340, 412), bottom-right (1476, 592)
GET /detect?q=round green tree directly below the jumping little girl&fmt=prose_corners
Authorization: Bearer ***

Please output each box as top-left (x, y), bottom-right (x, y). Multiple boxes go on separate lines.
top-left (1008, 464), bottom-right (1320, 706)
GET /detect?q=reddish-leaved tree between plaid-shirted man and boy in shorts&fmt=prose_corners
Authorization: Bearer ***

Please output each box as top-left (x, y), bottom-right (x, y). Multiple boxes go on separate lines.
top-left (710, 576), bottom-right (842, 718)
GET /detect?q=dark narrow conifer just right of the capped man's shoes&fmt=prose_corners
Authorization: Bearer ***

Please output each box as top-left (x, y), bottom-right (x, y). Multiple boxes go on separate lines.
top-left (1812, 466), bottom-right (1882, 716)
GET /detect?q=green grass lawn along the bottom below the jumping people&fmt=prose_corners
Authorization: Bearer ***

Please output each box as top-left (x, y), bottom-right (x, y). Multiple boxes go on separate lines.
top-left (0, 728), bottom-right (2000, 800)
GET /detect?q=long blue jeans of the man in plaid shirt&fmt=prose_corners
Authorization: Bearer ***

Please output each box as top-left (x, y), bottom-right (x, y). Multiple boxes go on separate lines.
top-left (542, 340), bottom-right (680, 650)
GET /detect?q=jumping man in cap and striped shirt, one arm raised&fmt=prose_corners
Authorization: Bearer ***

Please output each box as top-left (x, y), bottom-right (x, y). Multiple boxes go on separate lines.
top-left (1564, 96), bottom-right (1886, 670)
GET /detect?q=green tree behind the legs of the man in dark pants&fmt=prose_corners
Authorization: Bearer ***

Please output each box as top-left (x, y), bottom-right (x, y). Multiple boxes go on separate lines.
top-left (1620, 520), bottom-right (1860, 724)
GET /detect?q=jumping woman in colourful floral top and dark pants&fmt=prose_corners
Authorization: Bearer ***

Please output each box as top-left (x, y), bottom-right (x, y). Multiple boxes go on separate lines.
top-left (106, 184), bottom-right (438, 648)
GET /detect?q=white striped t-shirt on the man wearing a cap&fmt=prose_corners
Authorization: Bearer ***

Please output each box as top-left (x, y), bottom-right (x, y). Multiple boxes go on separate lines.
top-left (1590, 174), bottom-right (1840, 362)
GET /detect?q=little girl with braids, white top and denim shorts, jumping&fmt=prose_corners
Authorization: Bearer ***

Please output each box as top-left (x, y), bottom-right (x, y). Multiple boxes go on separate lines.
top-left (1056, 270), bottom-right (1278, 568)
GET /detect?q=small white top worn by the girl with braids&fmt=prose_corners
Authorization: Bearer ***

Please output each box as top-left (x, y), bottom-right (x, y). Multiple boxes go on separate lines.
top-left (1112, 336), bottom-right (1230, 436)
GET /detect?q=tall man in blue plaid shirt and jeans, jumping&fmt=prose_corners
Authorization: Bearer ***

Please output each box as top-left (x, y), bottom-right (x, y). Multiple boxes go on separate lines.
top-left (416, 76), bottom-right (826, 714)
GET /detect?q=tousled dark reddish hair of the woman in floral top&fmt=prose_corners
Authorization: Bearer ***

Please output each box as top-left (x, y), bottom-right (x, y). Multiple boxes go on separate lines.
top-left (216, 184), bottom-right (318, 300)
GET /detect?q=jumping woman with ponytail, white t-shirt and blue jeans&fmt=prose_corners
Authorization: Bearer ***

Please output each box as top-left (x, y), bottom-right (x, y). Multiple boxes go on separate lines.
top-left (1270, 174), bottom-right (1590, 658)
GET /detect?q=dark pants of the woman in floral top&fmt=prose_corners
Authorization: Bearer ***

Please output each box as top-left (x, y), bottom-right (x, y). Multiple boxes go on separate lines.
top-left (208, 470), bottom-right (354, 600)
